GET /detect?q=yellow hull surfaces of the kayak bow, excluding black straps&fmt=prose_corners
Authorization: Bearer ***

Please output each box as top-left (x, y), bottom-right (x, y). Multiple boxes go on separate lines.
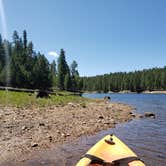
top-left (76, 135), bottom-right (145, 166)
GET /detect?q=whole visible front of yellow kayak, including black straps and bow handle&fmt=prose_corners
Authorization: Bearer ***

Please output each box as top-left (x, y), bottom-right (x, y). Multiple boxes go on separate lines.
top-left (76, 134), bottom-right (145, 166)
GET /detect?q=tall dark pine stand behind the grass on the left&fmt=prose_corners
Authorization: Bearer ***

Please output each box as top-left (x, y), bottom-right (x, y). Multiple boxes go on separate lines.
top-left (0, 30), bottom-right (81, 91)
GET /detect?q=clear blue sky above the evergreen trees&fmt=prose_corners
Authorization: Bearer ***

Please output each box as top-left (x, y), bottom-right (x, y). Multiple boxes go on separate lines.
top-left (0, 0), bottom-right (166, 76)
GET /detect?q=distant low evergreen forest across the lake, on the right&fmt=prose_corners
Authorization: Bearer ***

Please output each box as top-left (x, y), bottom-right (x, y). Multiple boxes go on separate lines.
top-left (82, 67), bottom-right (166, 92)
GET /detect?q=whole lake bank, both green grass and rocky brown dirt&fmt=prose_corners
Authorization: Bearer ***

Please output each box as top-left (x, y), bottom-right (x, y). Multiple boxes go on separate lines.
top-left (0, 91), bottom-right (133, 165)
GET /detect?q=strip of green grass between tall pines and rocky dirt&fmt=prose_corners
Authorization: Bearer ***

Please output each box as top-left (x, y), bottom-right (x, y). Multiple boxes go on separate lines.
top-left (0, 90), bottom-right (88, 107)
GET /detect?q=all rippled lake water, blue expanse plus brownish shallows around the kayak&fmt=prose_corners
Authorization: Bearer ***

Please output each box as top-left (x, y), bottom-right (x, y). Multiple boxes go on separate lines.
top-left (22, 94), bottom-right (166, 166)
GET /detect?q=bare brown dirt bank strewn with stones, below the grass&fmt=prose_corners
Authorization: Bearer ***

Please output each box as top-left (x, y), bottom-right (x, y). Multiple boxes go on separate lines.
top-left (0, 100), bottom-right (133, 165)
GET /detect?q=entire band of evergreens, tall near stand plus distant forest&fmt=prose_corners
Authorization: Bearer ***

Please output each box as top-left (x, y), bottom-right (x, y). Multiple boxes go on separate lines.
top-left (0, 30), bottom-right (166, 92)
